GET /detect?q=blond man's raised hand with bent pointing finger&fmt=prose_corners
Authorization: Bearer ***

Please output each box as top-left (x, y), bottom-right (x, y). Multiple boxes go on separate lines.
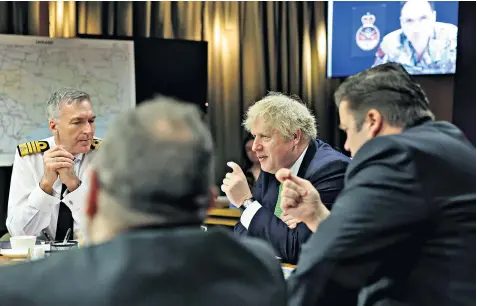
top-left (220, 162), bottom-right (252, 207)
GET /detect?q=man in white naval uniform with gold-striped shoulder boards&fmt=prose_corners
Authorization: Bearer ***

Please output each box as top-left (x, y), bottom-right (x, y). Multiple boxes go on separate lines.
top-left (6, 88), bottom-right (101, 240)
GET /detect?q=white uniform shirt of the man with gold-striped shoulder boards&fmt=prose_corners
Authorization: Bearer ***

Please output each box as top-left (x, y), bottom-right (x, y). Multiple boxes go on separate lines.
top-left (7, 137), bottom-right (94, 239)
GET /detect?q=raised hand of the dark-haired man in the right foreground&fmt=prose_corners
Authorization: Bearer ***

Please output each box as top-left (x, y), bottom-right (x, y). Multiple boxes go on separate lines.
top-left (275, 169), bottom-right (329, 232)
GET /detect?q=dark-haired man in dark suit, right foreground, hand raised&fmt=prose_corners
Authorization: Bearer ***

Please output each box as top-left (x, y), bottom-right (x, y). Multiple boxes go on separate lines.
top-left (276, 63), bottom-right (476, 306)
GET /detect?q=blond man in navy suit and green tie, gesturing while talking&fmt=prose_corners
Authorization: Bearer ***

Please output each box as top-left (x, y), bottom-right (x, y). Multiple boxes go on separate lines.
top-left (221, 92), bottom-right (349, 263)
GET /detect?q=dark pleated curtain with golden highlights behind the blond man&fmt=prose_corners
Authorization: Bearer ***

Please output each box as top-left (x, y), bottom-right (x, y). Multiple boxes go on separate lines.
top-left (71, 1), bottom-right (342, 183)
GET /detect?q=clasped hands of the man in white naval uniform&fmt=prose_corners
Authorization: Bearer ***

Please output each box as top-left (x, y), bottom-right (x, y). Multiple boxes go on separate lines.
top-left (40, 146), bottom-right (74, 194)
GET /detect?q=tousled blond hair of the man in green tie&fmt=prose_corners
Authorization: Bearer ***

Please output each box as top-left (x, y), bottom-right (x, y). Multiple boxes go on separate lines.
top-left (243, 92), bottom-right (318, 140)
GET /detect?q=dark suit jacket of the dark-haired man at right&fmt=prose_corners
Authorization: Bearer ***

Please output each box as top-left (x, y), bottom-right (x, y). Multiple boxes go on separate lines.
top-left (288, 121), bottom-right (476, 306)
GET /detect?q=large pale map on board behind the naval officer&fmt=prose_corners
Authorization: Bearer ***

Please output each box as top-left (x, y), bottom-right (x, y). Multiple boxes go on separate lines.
top-left (0, 35), bottom-right (136, 166)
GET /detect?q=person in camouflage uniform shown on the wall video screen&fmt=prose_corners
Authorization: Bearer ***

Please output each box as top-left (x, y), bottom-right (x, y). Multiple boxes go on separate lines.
top-left (373, 0), bottom-right (457, 74)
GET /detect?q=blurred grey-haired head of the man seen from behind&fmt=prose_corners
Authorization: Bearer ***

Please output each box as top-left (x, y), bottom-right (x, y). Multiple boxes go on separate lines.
top-left (92, 97), bottom-right (214, 223)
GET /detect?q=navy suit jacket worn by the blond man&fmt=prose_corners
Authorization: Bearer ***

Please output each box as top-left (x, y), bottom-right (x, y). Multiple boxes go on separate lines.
top-left (234, 140), bottom-right (350, 264)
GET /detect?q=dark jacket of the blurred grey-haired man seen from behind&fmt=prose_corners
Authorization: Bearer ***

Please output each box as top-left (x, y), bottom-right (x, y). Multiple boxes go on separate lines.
top-left (0, 228), bottom-right (287, 306)
